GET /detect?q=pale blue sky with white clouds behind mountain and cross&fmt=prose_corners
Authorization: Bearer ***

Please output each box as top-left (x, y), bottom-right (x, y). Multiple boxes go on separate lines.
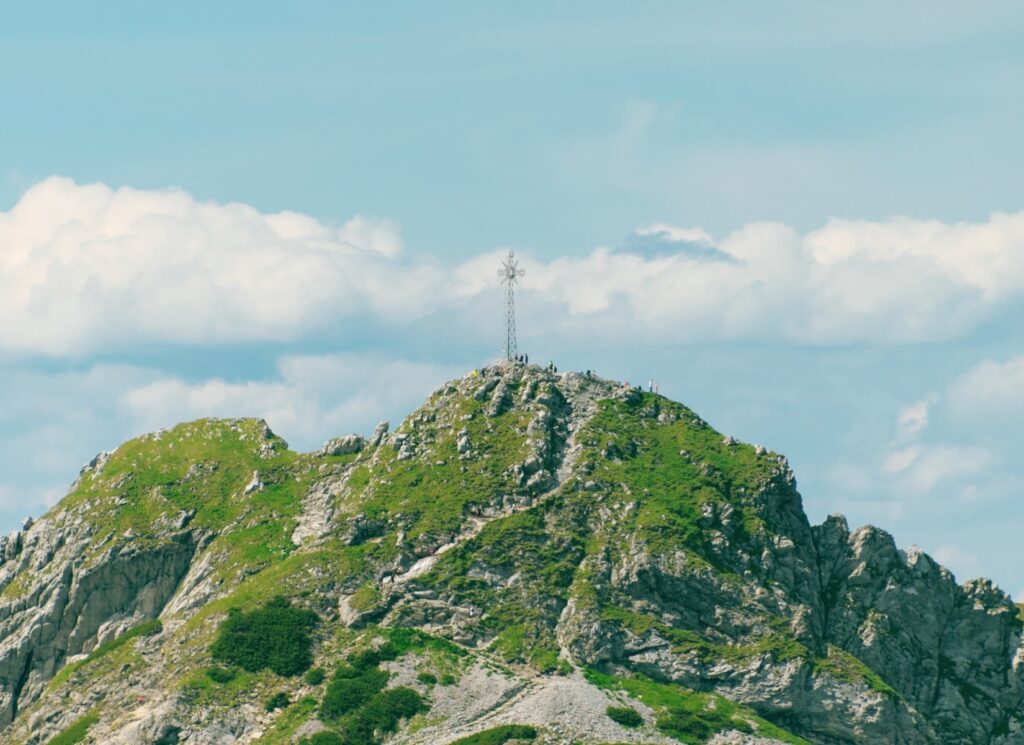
top-left (0, 2), bottom-right (1024, 594)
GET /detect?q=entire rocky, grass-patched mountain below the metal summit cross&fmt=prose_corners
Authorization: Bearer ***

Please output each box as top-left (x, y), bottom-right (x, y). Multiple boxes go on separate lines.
top-left (0, 363), bottom-right (1024, 745)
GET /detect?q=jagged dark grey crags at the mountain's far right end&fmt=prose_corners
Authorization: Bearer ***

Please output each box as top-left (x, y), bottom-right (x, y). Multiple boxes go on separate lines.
top-left (814, 516), bottom-right (1024, 743)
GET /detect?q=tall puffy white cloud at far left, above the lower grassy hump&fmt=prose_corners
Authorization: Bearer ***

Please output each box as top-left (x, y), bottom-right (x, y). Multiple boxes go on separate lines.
top-left (0, 178), bottom-right (428, 355)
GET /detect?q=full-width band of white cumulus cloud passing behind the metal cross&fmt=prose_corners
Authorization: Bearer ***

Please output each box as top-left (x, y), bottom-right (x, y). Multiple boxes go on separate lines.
top-left (6, 178), bottom-right (1024, 356)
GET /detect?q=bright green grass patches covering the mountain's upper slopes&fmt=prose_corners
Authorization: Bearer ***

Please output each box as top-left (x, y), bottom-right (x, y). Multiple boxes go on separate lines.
top-left (19, 380), bottom-right (866, 743)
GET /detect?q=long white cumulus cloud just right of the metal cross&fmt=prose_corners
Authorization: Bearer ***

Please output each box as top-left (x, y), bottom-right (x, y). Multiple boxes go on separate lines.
top-left (525, 213), bottom-right (1024, 344)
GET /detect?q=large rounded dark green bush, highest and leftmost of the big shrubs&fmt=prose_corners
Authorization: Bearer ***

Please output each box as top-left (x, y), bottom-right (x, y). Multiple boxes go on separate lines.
top-left (210, 597), bottom-right (318, 675)
